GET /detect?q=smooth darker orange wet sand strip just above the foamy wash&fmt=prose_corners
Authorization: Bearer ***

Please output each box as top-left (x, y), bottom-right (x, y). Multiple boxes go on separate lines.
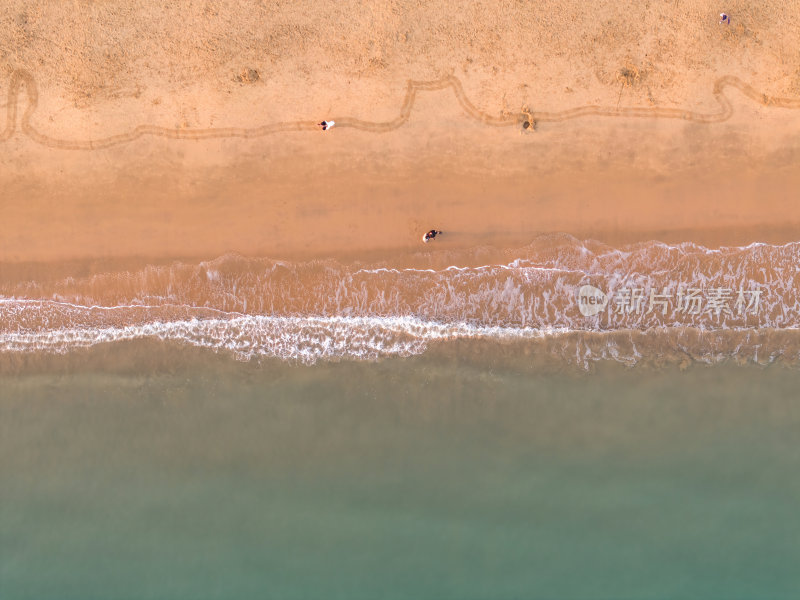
top-left (0, 154), bottom-right (800, 268)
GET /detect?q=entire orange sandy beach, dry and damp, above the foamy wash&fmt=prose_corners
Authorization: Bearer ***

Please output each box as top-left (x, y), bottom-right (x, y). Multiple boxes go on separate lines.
top-left (0, 0), bottom-right (800, 278)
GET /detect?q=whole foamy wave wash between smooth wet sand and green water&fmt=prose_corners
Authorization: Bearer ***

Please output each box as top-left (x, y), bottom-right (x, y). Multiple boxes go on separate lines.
top-left (0, 235), bottom-right (800, 366)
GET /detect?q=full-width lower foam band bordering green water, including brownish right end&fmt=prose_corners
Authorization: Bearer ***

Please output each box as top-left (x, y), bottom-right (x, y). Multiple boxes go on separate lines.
top-left (6, 315), bottom-right (800, 368)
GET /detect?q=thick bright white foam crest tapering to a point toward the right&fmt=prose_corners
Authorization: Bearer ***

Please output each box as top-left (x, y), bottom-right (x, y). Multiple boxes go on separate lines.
top-left (0, 315), bottom-right (570, 363)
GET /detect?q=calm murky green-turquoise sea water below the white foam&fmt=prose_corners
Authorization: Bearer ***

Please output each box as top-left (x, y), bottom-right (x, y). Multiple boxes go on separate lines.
top-left (0, 344), bottom-right (800, 600)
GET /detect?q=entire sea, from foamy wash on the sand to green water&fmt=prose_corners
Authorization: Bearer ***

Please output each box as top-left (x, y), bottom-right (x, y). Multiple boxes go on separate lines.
top-left (0, 236), bottom-right (800, 599)
